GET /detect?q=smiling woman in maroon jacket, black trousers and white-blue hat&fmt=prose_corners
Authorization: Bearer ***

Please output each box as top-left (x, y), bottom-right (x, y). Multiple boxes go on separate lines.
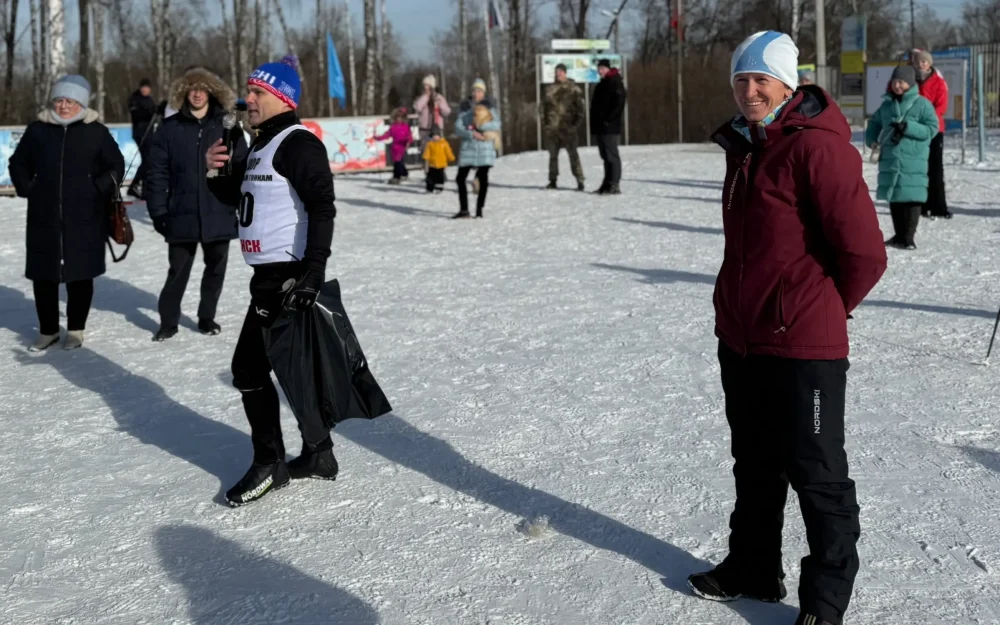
top-left (689, 31), bottom-right (886, 625)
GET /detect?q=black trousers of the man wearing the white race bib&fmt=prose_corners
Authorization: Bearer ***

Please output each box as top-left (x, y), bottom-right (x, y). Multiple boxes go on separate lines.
top-left (232, 262), bottom-right (333, 464)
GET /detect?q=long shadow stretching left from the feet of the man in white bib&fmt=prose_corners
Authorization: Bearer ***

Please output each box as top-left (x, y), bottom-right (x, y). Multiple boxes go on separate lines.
top-left (0, 285), bottom-right (251, 502)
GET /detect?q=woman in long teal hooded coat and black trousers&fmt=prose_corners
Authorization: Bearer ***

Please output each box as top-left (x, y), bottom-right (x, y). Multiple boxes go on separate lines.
top-left (865, 65), bottom-right (938, 250)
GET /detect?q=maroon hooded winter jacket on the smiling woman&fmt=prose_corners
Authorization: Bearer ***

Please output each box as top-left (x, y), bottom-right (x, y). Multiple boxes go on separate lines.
top-left (713, 86), bottom-right (886, 360)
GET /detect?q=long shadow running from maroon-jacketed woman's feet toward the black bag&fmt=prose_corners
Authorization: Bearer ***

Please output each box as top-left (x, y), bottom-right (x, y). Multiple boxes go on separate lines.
top-left (337, 415), bottom-right (797, 625)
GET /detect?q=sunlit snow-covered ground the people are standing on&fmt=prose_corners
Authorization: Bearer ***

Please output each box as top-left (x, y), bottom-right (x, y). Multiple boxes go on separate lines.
top-left (0, 145), bottom-right (1000, 625)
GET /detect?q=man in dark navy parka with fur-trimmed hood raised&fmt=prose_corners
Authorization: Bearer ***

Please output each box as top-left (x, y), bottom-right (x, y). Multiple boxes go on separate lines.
top-left (146, 67), bottom-right (247, 341)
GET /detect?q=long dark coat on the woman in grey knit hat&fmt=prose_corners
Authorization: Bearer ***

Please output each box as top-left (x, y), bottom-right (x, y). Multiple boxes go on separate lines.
top-left (9, 110), bottom-right (125, 282)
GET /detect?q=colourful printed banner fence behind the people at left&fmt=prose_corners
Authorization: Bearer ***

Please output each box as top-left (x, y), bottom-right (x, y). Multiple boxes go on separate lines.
top-left (0, 117), bottom-right (406, 191)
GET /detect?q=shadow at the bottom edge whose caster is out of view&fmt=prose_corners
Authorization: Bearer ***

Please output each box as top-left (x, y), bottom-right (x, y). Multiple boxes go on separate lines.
top-left (155, 525), bottom-right (379, 625)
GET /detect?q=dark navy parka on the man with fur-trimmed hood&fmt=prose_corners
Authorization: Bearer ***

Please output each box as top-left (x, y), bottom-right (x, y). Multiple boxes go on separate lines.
top-left (146, 99), bottom-right (247, 243)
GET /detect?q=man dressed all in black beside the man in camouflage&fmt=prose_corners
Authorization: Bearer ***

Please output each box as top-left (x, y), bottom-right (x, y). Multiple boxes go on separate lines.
top-left (590, 59), bottom-right (627, 195)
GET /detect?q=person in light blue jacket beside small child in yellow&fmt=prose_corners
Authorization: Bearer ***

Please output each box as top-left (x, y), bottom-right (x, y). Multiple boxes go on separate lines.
top-left (454, 78), bottom-right (500, 219)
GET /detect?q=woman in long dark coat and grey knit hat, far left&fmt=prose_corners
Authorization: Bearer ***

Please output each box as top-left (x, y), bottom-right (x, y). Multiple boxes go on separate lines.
top-left (9, 75), bottom-right (125, 351)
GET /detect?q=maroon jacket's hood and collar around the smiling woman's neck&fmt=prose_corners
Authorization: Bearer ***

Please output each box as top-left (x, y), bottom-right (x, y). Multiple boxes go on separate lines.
top-left (712, 85), bottom-right (851, 150)
